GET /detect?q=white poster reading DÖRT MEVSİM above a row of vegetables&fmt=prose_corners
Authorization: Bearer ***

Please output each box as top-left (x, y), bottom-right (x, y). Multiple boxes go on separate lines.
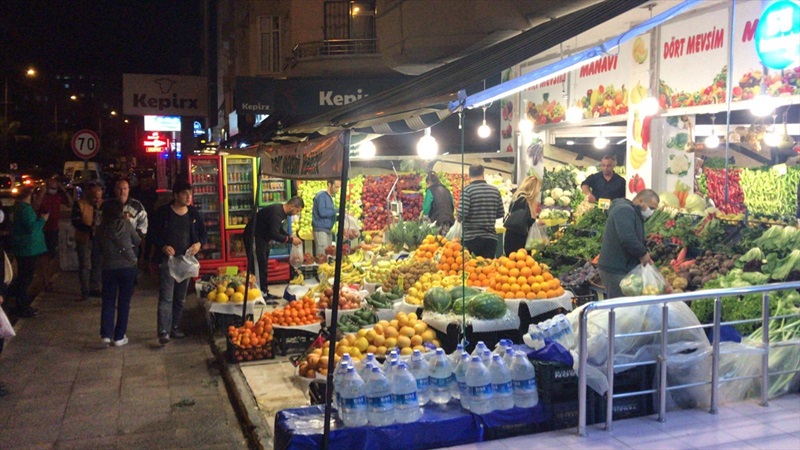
top-left (658, 2), bottom-right (732, 109)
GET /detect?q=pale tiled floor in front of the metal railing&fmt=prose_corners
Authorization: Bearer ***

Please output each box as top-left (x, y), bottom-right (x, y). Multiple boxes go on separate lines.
top-left (440, 394), bottom-right (800, 450)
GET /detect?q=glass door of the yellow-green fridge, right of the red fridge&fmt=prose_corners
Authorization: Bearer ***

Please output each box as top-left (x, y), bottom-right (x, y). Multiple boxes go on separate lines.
top-left (225, 157), bottom-right (255, 229)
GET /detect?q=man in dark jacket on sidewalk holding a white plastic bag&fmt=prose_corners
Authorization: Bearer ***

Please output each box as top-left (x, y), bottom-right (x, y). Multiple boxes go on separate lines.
top-left (149, 180), bottom-right (208, 345)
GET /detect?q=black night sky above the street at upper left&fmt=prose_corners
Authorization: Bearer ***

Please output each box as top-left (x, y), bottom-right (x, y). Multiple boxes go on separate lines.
top-left (0, 0), bottom-right (203, 80)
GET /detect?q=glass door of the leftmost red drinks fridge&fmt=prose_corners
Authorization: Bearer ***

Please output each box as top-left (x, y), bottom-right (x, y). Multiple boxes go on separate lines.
top-left (191, 159), bottom-right (223, 261)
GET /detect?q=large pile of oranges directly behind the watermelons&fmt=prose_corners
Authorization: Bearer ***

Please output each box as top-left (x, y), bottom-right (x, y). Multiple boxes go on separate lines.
top-left (484, 249), bottom-right (564, 300)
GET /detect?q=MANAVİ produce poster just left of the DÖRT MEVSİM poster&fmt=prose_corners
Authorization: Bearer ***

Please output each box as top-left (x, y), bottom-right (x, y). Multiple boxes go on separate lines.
top-left (570, 39), bottom-right (636, 118)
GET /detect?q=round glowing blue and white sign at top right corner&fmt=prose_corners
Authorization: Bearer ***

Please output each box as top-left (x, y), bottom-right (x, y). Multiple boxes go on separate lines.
top-left (755, 0), bottom-right (800, 70)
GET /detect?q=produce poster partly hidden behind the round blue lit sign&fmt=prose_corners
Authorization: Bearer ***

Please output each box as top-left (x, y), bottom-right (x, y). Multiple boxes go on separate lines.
top-left (733, 1), bottom-right (800, 101)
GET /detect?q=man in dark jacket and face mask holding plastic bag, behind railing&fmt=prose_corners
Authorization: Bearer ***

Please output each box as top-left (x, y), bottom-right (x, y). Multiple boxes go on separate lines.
top-left (597, 189), bottom-right (659, 298)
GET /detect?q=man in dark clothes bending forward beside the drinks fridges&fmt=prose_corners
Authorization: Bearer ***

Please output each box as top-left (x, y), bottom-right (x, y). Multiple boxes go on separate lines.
top-left (244, 196), bottom-right (305, 299)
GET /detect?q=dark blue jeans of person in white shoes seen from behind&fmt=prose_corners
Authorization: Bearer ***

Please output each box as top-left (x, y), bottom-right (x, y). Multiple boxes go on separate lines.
top-left (100, 267), bottom-right (137, 341)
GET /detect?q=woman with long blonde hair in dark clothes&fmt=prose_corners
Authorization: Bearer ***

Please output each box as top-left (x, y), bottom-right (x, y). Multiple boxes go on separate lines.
top-left (503, 175), bottom-right (542, 255)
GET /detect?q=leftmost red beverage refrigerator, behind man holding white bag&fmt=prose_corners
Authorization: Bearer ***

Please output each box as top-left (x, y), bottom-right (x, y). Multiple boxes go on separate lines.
top-left (189, 156), bottom-right (225, 273)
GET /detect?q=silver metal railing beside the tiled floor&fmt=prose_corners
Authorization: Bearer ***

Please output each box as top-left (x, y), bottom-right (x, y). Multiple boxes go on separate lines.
top-left (577, 282), bottom-right (800, 436)
